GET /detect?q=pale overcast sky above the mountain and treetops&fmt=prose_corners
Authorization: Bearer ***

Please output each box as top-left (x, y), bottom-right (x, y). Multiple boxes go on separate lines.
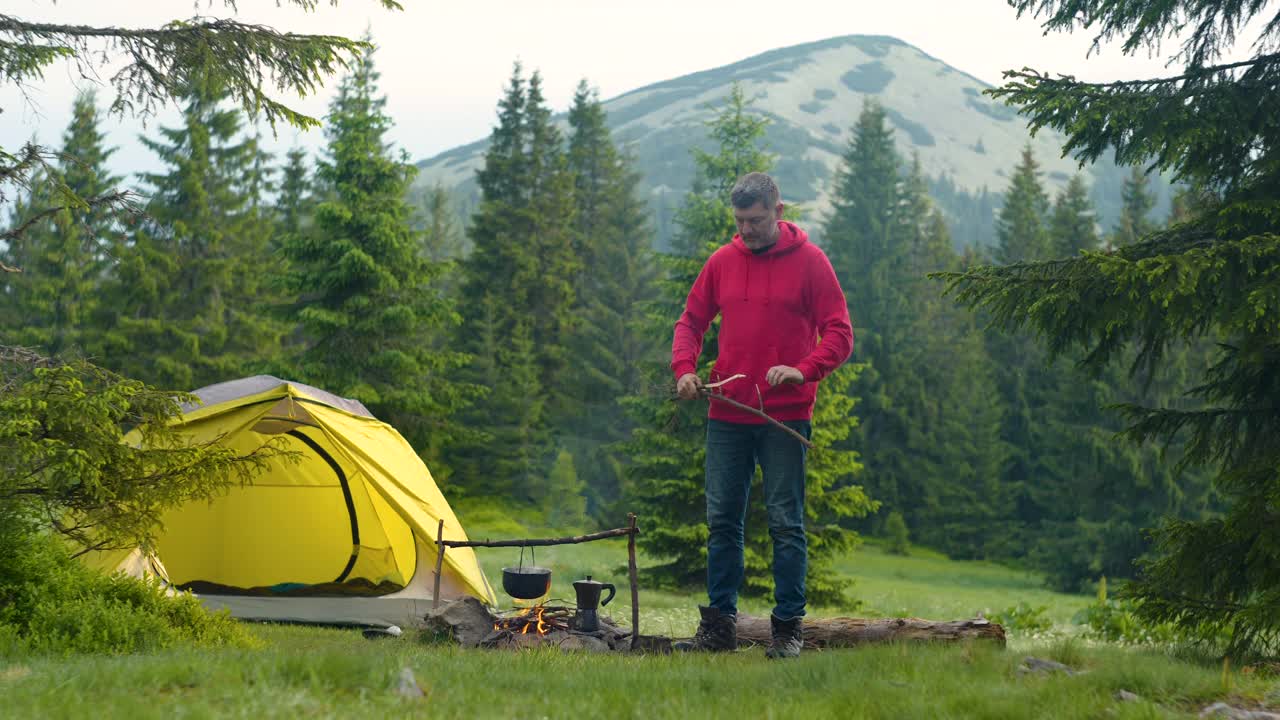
top-left (0, 0), bottom-right (1254, 173)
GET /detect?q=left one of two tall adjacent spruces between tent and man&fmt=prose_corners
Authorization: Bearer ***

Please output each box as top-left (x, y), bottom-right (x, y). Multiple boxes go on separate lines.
top-left (454, 63), bottom-right (581, 501)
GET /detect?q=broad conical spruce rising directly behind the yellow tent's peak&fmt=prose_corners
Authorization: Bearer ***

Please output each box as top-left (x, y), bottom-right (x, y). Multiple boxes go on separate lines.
top-left (96, 76), bottom-right (284, 389)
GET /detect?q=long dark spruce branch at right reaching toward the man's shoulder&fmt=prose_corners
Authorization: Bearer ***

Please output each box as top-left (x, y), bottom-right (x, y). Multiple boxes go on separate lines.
top-left (929, 221), bottom-right (1280, 374)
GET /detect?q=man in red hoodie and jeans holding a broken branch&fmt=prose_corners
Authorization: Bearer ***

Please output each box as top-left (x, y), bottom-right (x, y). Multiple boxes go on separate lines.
top-left (671, 173), bottom-right (854, 657)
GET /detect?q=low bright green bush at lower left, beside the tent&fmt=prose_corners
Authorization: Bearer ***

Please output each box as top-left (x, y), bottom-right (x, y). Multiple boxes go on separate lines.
top-left (0, 528), bottom-right (253, 655)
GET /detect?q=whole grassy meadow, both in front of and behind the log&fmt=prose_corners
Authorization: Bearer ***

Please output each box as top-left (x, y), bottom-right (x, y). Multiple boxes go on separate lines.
top-left (0, 502), bottom-right (1280, 720)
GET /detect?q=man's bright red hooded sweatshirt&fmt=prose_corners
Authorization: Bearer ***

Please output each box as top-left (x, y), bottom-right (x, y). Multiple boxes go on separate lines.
top-left (671, 222), bottom-right (854, 424)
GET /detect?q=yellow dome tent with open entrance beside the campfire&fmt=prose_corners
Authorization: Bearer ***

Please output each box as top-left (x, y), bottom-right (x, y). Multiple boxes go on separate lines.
top-left (88, 375), bottom-right (494, 625)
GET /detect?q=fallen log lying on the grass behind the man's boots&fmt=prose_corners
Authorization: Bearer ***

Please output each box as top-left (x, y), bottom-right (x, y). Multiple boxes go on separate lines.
top-left (737, 615), bottom-right (1005, 648)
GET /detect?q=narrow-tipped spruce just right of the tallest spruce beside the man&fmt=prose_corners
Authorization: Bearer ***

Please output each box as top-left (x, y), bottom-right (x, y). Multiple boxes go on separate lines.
top-left (896, 156), bottom-right (1012, 557)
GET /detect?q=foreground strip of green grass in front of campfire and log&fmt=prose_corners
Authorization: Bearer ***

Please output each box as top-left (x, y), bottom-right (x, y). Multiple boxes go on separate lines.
top-left (0, 626), bottom-right (1270, 720)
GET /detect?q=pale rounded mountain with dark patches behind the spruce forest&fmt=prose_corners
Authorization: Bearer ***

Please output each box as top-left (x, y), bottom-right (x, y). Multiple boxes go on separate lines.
top-left (417, 35), bottom-right (1170, 246)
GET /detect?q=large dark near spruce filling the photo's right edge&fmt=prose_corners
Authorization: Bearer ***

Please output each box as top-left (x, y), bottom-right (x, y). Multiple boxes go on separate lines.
top-left (950, 0), bottom-right (1280, 652)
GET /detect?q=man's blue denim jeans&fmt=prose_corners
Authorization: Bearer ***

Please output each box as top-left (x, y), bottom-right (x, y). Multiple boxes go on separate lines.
top-left (707, 420), bottom-right (812, 620)
